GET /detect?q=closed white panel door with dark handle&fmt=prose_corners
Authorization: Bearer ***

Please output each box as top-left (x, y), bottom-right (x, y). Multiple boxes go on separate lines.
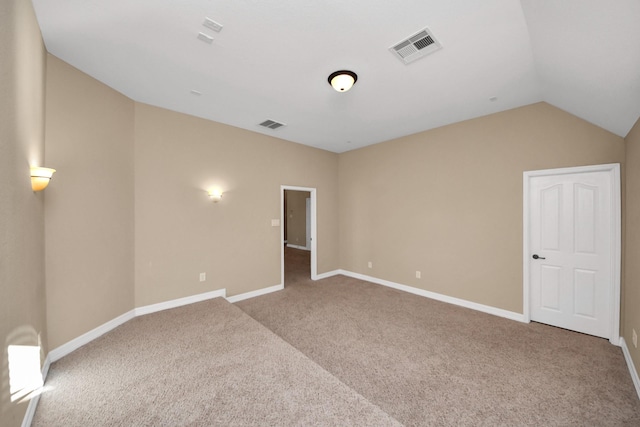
top-left (528, 171), bottom-right (618, 339)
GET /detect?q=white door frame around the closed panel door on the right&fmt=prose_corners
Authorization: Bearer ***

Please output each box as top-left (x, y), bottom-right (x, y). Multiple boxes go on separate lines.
top-left (522, 163), bottom-right (622, 345)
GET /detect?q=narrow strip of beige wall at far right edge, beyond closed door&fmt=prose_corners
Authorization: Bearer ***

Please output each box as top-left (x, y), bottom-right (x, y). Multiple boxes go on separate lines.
top-left (622, 115), bottom-right (640, 372)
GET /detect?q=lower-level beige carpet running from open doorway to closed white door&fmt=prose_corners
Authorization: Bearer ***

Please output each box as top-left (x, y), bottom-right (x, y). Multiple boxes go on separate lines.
top-left (237, 248), bottom-right (640, 426)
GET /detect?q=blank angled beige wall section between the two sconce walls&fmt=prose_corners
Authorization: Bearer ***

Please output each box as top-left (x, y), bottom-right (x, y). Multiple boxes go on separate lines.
top-left (46, 55), bottom-right (134, 348)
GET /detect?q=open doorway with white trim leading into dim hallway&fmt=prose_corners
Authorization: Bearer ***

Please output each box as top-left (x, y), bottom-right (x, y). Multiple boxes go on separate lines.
top-left (280, 185), bottom-right (317, 286)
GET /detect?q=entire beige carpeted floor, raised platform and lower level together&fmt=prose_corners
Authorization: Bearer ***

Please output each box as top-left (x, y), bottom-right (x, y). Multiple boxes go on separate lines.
top-left (34, 248), bottom-right (640, 426)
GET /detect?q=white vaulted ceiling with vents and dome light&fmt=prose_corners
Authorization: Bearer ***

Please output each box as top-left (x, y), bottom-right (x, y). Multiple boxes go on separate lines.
top-left (33, 0), bottom-right (640, 153)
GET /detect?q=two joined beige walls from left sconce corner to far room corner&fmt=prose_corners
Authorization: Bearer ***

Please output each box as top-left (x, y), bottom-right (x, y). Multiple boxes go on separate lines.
top-left (40, 55), bottom-right (338, 348)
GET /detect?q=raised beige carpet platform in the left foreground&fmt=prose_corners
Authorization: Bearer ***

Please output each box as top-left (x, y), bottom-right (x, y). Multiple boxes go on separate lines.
top-left (33, 298), bottom-right (399, 427)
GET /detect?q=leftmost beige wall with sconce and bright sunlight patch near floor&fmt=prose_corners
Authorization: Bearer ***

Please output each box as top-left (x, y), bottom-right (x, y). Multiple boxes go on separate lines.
top-left (0, 0), bottom-right (47, 427)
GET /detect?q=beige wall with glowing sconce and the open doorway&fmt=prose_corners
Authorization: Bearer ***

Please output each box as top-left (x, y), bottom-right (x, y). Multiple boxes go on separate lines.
top-left (135, 103), bottom-right (338, 306)
